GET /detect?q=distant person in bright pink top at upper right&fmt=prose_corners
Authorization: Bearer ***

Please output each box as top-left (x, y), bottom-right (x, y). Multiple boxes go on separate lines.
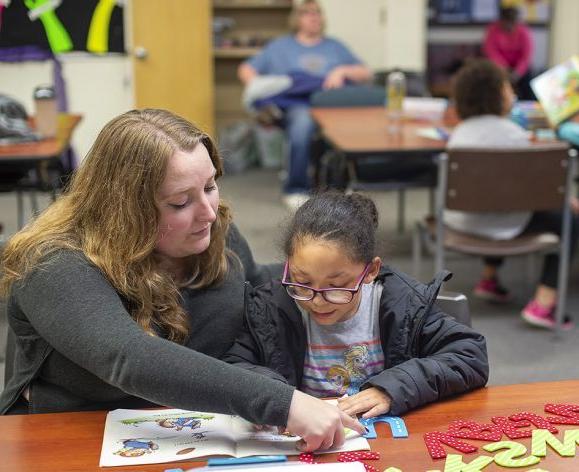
top-left (483, 7), bottom-right (533, 99)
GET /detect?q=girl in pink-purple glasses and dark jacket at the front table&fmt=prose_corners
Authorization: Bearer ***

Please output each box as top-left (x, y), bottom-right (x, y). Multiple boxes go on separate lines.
top-left (225, 192), bottom-right (488, 417)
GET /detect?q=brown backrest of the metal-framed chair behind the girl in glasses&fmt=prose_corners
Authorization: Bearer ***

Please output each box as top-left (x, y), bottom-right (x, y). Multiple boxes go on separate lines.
top-left (439, 143), bottom-right (569, 212)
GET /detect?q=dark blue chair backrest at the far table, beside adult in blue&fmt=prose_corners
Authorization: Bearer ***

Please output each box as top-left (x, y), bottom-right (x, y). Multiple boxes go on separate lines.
top-left (310, 85), bottom-right (386, 108)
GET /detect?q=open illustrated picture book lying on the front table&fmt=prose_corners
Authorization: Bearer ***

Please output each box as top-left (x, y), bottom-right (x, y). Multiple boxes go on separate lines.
top-left (99, 409), bottom-right (370, 467)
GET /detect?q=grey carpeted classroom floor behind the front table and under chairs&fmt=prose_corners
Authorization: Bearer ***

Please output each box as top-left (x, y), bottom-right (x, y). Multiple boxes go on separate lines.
top-left (0, 169), bottom-right (579, 389)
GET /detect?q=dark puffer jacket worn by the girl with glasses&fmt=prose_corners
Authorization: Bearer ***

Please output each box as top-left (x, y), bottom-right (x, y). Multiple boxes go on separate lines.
top-left (224, 267), bottom-right (489, 415)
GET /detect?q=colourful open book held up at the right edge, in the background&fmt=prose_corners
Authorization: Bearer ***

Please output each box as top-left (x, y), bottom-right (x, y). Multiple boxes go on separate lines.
top-left (531, 56), bottom-right (579, 126)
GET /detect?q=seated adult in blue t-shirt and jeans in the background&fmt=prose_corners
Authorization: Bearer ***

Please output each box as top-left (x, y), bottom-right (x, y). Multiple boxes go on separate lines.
top-left (238, 0), bottom-right (372, 210)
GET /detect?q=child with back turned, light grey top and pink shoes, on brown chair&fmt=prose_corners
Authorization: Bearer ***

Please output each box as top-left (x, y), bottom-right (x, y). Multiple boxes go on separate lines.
top-left (444, 60), bottom-right (577, 329)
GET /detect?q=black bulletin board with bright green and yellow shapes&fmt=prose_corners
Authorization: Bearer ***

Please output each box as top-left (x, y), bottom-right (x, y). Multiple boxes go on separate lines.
top-left (0, 0), bottom-right (125, 54)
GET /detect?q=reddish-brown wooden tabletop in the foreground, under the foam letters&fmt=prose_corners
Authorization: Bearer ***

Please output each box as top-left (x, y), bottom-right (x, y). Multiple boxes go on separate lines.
top-left (0, 380), bottom-right (579, 472)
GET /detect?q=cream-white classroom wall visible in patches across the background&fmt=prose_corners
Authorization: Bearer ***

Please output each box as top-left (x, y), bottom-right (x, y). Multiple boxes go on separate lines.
top-left (0, 0), bottom-right (579, 157)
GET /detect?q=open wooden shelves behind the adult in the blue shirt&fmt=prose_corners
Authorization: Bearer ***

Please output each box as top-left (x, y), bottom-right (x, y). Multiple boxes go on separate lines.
top-left (213, 0), bottom-right (292, 129)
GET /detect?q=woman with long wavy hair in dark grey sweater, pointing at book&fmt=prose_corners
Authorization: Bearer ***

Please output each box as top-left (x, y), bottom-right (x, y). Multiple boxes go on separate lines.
top-left (0, 110), bottom-right (361, 449)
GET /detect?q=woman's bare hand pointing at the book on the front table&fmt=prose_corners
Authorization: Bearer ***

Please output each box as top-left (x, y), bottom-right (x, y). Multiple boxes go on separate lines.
top-left (287, 390), bottom-right (365, 452)
